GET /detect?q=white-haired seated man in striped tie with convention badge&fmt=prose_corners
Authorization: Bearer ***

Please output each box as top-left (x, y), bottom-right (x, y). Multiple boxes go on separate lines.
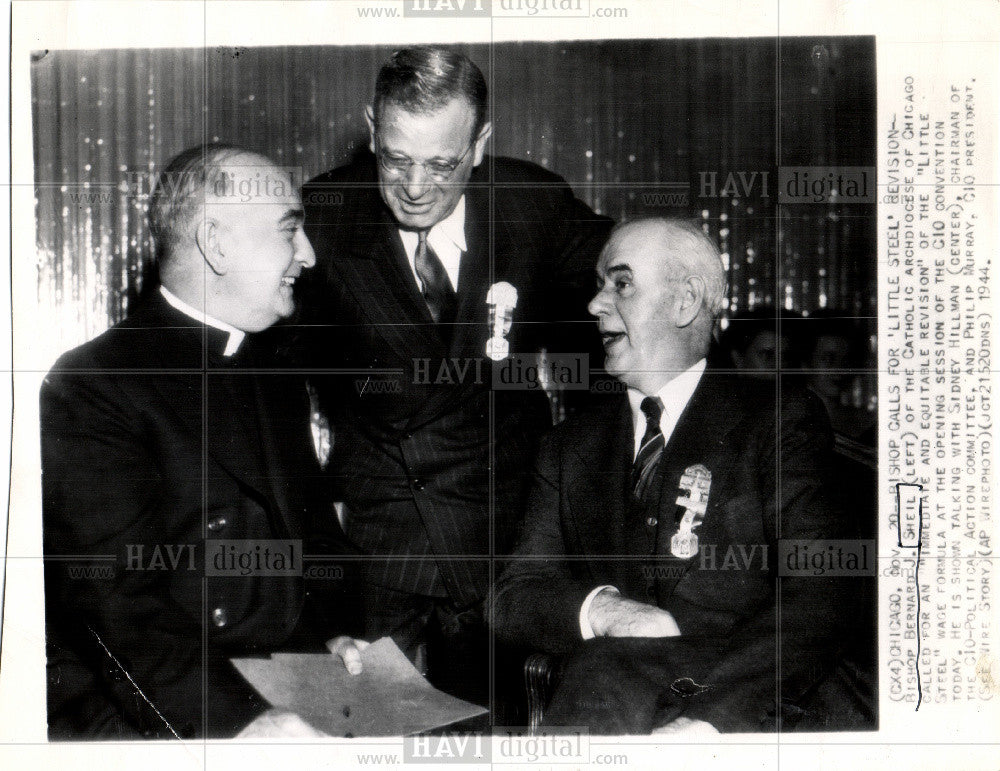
top-left (493, 219), bottom-right (873, 733)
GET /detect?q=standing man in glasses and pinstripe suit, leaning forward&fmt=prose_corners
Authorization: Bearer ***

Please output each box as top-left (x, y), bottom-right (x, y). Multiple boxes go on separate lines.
top-left (301, 46), bottom-right (611, 702)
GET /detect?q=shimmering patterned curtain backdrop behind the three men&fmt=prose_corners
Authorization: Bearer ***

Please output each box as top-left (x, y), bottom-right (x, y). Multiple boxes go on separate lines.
top-left (32, 38), bottom-right (876, 370)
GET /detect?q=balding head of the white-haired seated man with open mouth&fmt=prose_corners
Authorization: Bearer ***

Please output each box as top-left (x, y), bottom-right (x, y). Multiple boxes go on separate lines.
top-left (589, 218), bottom-right (725, 394)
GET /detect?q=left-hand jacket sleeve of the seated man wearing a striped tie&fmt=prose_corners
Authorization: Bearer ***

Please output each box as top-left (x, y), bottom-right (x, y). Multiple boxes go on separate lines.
top-left (493, 431), bottom-right (596, 653)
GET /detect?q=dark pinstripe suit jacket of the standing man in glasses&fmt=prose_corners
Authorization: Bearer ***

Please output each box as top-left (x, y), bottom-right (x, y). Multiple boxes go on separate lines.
top-left (300, 156), bottom-right (610, 605)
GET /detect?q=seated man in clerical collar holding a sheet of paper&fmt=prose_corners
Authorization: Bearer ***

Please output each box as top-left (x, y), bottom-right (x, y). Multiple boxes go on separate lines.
top-left (41, 145), bottom-right (361, 739)
